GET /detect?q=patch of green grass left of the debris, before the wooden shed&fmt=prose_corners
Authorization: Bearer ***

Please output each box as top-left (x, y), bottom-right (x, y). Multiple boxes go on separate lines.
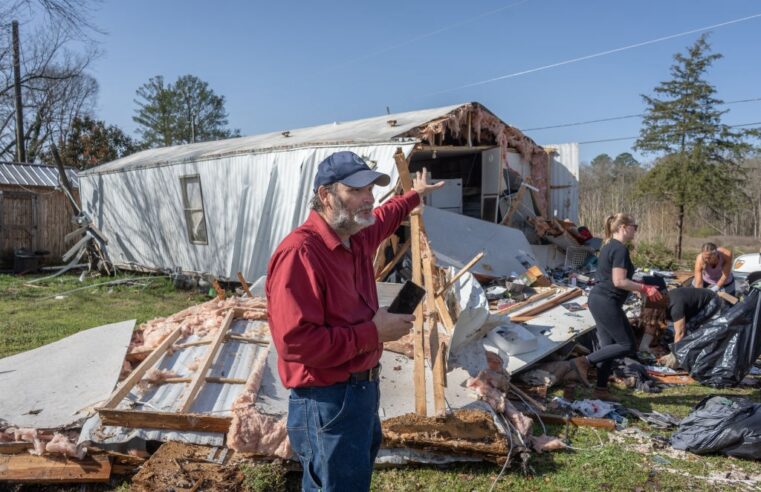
top-left (0, 274), bottom-right (207, 357)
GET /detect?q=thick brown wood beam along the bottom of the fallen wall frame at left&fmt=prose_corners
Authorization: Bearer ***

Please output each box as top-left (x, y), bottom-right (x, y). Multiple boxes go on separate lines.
top-left (98, 408), bottom-right (232, 434)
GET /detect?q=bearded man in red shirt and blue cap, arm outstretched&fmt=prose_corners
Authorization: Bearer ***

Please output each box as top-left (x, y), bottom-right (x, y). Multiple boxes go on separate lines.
top-left (266, 152), bottom-right (444, 491)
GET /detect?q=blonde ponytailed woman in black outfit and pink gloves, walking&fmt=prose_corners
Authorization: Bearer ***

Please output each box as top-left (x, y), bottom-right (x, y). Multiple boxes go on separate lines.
top-left (572, 213), bottom-right (661, 400)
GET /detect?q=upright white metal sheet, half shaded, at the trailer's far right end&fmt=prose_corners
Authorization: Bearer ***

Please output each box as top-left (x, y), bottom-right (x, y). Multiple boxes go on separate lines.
top-left (544, 143), bottom-right (579, 223)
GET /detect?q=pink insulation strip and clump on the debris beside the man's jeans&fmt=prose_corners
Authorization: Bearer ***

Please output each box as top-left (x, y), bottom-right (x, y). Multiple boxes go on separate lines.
top-left (227, 349), bottom-right (292, 459)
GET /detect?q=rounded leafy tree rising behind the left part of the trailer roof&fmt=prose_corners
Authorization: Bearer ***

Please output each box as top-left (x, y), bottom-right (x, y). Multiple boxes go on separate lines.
top-left (132, 75), bottom-right (239, 147)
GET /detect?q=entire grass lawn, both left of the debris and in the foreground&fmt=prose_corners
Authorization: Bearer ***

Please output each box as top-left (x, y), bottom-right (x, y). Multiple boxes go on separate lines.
top-left (0, 275), bottom-right (761, 491)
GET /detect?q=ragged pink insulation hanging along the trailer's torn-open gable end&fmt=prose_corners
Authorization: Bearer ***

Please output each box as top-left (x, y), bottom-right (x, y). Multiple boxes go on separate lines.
top-left (399, 103), bottom-right (549, 215)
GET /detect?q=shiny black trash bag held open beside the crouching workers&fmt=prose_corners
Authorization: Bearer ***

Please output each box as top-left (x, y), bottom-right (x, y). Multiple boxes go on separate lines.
top-left (671, 289), bottom-right (761, 388)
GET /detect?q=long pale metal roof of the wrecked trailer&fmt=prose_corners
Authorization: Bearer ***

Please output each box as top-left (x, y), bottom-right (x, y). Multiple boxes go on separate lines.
top-left (82, 102), bottom-right (533, 175)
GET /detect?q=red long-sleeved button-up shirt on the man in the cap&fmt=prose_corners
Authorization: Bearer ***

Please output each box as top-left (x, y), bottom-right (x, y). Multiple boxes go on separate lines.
top-left (266, 190), bottom-right (420, 388)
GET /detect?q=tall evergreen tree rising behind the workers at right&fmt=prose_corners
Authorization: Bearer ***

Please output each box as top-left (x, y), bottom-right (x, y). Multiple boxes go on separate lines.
top-left (635, 35), bottom-right (750, 259)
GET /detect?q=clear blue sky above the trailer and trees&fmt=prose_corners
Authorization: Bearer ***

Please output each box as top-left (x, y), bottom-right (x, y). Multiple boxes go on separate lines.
top-left (83, 0), bottom-right (761, 165)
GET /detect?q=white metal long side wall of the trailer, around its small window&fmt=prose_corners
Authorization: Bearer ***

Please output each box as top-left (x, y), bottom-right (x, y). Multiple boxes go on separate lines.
top-left (80, 142), bottom-right (415, 279)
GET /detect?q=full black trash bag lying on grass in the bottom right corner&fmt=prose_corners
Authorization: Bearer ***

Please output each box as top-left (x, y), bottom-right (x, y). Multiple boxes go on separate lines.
top-left (671, 396), bottom-right (761, 460)
